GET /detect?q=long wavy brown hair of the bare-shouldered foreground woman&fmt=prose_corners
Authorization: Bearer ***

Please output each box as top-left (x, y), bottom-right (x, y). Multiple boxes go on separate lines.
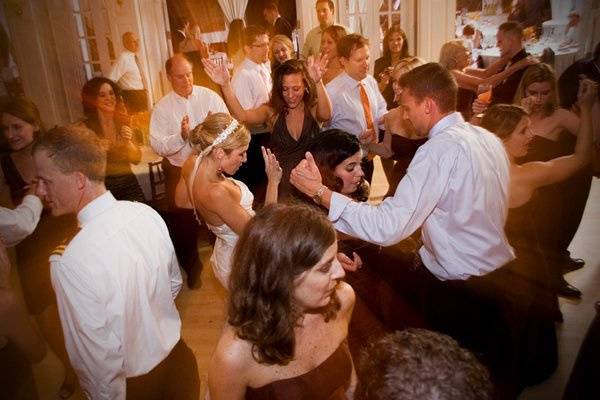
top-left (228, 204), bottom-right (340, 365)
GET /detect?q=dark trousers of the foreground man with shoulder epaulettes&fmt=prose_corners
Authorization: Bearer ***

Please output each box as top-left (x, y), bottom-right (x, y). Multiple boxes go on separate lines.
top-left (127, 340), bottom-right (200, 400)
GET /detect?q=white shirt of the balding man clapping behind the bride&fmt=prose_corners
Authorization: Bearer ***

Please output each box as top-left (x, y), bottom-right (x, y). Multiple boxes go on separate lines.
top-left (150, 86), bottom-right (229, 167)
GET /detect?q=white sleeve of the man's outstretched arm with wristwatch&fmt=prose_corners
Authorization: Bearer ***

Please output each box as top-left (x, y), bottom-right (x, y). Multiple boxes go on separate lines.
top-left (329, 142), bottom-right (456, 246)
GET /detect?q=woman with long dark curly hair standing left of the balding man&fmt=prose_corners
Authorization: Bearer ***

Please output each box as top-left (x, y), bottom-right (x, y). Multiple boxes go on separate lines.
top-left (81, 77), bottom-right (145, 201)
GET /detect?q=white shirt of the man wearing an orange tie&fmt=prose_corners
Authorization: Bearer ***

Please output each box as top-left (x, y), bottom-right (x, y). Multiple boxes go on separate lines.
top-left (325, 72), bottom-right (387, 136)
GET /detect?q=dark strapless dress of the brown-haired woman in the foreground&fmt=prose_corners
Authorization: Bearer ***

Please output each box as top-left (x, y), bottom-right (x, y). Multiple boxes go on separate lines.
top-left (245, 342), bottom-right (352, 400)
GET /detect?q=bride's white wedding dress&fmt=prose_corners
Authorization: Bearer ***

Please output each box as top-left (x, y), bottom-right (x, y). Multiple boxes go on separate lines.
top-left (188, 157), bottom-right (254, 289)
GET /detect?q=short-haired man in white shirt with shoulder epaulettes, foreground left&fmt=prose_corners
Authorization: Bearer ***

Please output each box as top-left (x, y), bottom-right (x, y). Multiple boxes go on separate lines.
top-left (33, 127), bottom-right (199, 399)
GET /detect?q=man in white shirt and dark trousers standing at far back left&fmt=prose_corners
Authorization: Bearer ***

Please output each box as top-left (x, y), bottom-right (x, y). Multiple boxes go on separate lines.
top-left (107, 32), bottom-right (148, 113)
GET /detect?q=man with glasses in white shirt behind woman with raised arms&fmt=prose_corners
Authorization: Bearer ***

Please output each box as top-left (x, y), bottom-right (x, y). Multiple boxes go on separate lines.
top-left (231, 25), bottom-right (273, 194)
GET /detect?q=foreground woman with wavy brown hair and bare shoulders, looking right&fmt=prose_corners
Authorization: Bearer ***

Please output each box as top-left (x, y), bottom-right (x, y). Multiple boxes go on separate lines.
top-left (208, 205), bottom-right (355, 400)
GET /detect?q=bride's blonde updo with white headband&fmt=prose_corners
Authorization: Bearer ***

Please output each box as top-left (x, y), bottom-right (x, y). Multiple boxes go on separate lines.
top-left (188, 113), bottom-right (250, 153)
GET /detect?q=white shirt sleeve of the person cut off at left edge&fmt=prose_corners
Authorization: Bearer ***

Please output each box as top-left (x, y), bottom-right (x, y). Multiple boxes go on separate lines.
top-left (0, 194), bottom-right (43, 247)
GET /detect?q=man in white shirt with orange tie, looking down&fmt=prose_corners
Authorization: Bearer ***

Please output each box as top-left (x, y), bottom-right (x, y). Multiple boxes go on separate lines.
top-left (326, 34), bottom-right (387, 182)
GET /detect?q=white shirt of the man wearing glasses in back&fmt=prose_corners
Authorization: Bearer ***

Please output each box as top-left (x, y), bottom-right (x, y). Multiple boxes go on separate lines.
top-left (231, 57), bottom-right (273, 133)
